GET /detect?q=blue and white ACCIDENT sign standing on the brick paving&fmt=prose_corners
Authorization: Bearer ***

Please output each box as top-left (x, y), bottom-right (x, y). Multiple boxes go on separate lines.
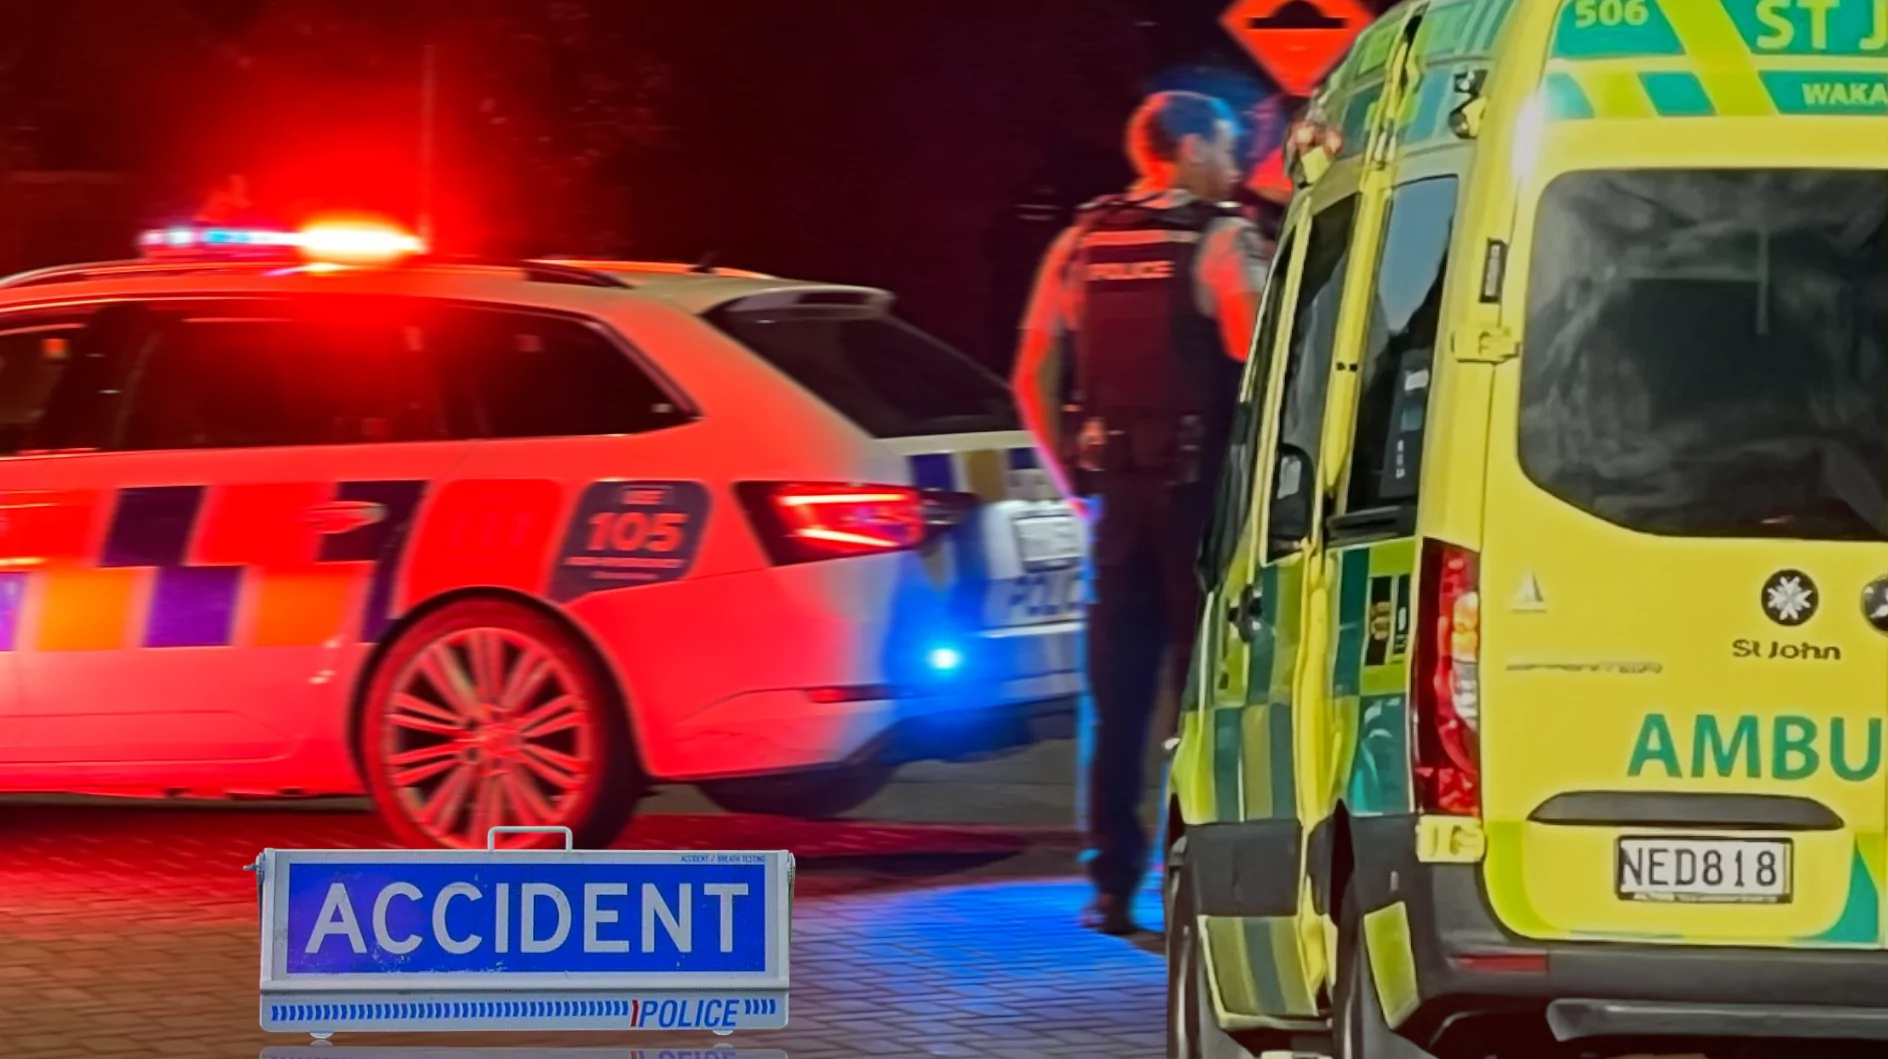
top-left (255, 838), bottom-right (793, 1034)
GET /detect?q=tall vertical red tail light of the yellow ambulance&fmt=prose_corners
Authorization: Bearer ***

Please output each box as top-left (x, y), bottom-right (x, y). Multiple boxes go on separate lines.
top-left (1412, 540), bottom-right (1482, 815)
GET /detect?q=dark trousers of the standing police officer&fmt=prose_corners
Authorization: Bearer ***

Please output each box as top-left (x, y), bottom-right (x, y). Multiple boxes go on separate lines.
top-left (1082, 474), bottom-right (1212, 899)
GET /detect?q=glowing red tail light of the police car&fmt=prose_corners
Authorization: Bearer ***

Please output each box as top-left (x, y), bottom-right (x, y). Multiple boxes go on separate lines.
top-left (738, 481), bottom-right (976, 564)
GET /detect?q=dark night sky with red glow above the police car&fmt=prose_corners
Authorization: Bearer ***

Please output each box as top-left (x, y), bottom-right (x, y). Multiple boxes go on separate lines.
top-left (0, 0), bottom-right (1397, 368)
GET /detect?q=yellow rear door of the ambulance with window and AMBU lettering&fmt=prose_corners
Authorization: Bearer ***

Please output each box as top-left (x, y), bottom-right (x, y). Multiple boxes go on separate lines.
top-left (1480, 167), bottom-right (1888, 946)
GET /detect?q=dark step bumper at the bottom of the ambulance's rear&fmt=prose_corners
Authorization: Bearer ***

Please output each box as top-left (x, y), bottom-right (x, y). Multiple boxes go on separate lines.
top-left (1546, 1000), bottom-right (1888, 1042)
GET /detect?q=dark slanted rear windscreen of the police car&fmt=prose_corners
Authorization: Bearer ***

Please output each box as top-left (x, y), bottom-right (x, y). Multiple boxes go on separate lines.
top-left (710, 306), bottom-right (1020, 438)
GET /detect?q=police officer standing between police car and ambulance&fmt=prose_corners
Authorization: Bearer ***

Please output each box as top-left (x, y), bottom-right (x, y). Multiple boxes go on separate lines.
top-left (1012, 92), bottom-right (1271, 934)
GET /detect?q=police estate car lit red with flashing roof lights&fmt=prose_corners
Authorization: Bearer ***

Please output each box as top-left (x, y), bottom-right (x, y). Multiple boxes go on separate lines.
top-left (0, 225), bottom-right (1084, 848)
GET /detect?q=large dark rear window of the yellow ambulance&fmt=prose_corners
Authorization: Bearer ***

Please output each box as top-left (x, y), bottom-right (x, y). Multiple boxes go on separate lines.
top-left (1520, 170), bottom-right (1888, 540)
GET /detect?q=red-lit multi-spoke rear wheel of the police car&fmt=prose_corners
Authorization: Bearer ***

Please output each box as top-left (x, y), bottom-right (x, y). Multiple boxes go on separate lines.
top-left (359, 600), bottom-right (646, 849)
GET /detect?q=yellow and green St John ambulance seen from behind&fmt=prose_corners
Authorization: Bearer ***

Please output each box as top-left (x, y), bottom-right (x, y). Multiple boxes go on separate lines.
top-left (1167, 0), bottom-right (1888, 1059)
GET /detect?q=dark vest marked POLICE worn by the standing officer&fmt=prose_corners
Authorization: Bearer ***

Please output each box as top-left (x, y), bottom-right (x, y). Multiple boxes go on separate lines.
top-left (1070, 196), bottom-right (1240, 479)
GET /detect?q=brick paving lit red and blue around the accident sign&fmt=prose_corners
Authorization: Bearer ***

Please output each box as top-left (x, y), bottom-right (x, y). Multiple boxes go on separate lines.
top-left (0, 802), bottom-right (1165, 1059)
